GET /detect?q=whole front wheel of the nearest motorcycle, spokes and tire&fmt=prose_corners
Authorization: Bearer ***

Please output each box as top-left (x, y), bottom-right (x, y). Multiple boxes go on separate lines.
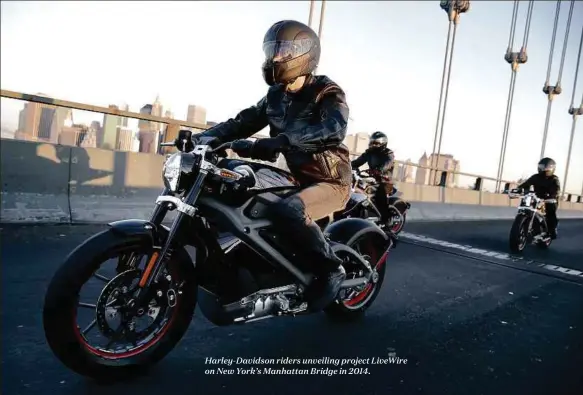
top-left (43, 232), bottom-right (196, 379)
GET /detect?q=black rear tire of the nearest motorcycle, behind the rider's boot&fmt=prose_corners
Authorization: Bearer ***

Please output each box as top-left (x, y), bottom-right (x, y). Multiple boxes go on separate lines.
top-left (324, 234), bottom-right (387, 322)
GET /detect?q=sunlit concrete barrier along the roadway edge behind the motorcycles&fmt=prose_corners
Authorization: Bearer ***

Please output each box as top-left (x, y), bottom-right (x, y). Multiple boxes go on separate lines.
top-left (0, 139), bottom-right (583, 223)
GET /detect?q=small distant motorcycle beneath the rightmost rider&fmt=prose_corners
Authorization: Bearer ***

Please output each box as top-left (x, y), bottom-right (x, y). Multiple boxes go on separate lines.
top-left (508, 186), bottom-right (557, 253)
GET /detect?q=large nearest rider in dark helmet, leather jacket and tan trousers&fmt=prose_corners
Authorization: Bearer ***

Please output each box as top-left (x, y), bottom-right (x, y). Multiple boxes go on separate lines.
top-left (181, 20), bottom-right (351, 311)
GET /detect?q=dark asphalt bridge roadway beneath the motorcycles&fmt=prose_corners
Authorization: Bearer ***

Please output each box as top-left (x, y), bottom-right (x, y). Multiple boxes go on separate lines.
top-left (1, 220), bottom-right (583, 395)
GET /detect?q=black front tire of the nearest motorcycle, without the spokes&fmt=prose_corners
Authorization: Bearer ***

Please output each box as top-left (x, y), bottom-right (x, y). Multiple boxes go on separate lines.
top-left (43, 230), bottom-right (197, 380)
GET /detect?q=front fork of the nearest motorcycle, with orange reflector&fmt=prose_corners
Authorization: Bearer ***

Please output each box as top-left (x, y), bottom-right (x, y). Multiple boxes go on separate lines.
top-left (135, 169), bottom-right (208, 306)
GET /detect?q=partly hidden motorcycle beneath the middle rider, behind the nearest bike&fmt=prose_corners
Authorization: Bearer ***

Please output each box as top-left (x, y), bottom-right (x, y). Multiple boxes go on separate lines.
top-left (318, 170), bottom-right (411, 235)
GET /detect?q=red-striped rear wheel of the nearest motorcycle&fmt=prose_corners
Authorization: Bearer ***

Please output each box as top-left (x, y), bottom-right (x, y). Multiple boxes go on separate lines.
top-left (325, 235), bottom-right (387, 320)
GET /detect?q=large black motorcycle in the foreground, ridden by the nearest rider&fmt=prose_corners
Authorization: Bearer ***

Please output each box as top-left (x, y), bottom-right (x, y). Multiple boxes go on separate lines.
top-left (43, 136), bottom-right (394, 379)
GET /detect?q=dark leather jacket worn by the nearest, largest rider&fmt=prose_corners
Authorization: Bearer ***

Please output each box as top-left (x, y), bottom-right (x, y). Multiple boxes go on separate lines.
top-left (202, 76), bottom-right (352, 186)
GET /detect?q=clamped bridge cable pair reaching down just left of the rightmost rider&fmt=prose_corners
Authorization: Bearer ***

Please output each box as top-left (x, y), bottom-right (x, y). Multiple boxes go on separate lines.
top-left (496, 0), bottom-right (534, 192)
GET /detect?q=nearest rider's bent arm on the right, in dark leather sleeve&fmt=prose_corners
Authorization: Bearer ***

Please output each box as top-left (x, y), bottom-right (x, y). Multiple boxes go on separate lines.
top-left (282, 86), bottom-right (349, 150)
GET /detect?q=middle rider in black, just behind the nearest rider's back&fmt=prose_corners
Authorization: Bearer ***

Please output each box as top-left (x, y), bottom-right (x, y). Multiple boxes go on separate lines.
top-left (351, 132), bottom-right (395, 224)
